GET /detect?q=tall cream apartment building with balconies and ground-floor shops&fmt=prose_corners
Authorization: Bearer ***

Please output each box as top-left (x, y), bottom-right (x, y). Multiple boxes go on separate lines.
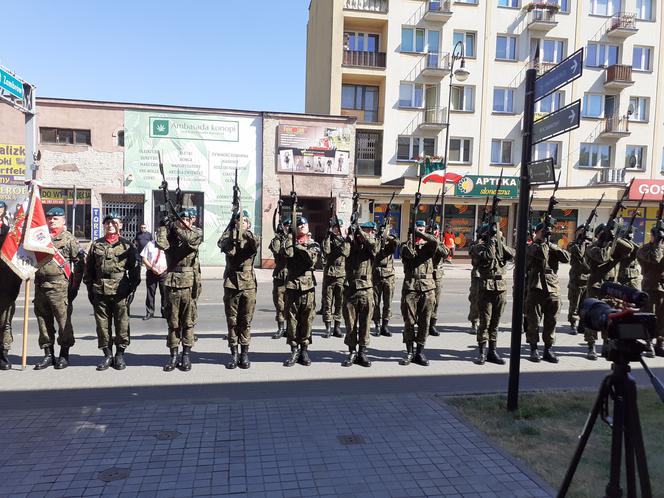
top-left (306, 0), bottom-right (664, 247)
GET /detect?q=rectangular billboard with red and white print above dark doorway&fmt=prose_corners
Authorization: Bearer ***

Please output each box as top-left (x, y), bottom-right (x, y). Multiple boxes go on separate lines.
top-left (277, 125), bottom-right (352, 175)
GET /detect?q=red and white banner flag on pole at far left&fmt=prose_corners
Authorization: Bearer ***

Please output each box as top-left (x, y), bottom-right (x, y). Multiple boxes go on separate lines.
top-left (1, 182), bottom-right (56, 280)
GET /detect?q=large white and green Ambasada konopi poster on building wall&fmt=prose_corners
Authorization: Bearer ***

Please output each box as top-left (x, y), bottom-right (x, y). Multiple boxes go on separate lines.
top-left (125, 111), bottom-right (262, 266)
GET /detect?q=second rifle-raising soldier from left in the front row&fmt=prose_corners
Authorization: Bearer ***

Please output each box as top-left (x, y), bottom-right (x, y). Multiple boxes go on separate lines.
top-left (217, 211), bottom-right (261, 369)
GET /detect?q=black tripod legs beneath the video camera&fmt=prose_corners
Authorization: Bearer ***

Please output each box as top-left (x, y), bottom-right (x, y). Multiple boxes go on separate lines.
top-left (558, 351), bottom-right (652, 498)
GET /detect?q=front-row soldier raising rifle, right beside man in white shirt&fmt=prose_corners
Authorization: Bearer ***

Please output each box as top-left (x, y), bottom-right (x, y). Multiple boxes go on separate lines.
top-left (157, 209), bottom-right (203, 372)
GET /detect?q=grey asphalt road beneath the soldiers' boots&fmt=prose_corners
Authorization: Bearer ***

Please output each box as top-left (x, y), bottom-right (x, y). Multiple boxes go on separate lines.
top-left (0, 265), bottom-right (664, 408)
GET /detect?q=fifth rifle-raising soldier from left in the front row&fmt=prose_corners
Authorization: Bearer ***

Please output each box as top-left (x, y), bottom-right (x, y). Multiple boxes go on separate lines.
top-left (399, 220), bottom-right (438, 366)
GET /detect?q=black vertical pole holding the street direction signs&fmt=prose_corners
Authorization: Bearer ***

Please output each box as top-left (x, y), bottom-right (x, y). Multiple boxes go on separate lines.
top-left (507, 69), bottom-right (537, 411)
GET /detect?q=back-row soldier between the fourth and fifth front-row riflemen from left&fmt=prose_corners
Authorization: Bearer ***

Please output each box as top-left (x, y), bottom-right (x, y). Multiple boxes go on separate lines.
top-left (373, 228), bottom-right (399, 337)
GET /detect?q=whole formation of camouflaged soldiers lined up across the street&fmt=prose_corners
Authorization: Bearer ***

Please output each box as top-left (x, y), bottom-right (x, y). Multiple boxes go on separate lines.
top-left (0, 172), bottom-right (664, 372)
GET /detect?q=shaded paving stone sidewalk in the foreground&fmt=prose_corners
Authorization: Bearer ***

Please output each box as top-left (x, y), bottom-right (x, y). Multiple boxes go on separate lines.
top-left (0, 392), bottom-right (553, 497)
